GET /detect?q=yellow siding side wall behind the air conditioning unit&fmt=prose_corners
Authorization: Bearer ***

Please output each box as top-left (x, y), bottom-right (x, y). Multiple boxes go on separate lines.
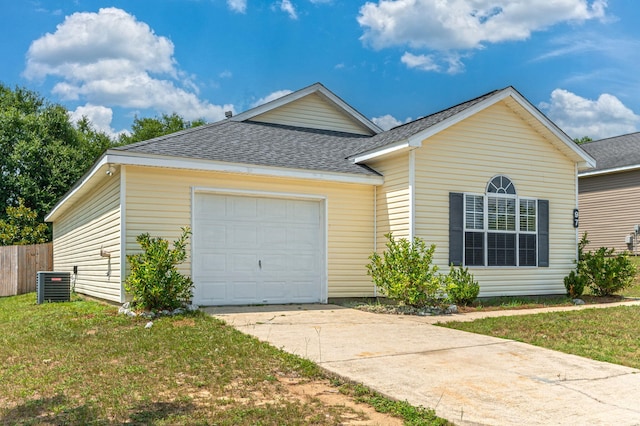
top-left (53, 168), bottom-right (122, 302)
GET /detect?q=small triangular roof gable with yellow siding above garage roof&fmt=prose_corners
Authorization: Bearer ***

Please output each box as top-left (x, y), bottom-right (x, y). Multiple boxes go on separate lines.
top-left (231, 83), bottom-right (382, 136)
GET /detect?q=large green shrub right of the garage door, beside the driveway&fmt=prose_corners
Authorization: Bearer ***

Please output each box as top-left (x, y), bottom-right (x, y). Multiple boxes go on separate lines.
top-left (367, 233), bottom-right (446, 308)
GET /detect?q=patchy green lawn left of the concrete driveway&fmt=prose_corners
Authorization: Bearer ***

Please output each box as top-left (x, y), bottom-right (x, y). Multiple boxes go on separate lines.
top-left (0, 293), bottom-right (445, 425)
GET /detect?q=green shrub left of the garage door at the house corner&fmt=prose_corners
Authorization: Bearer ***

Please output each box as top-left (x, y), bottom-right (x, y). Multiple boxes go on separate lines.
top-left (125, 228), bottom-right (193, 310)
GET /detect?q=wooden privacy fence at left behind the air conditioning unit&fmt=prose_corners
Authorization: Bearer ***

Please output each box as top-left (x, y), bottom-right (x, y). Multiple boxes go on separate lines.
top-left (0, 243), bottom-right (53, 297)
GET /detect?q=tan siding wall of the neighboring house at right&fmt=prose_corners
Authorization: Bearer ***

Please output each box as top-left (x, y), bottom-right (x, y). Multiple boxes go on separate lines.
top-left (578, 170), bottom-right (640, 253)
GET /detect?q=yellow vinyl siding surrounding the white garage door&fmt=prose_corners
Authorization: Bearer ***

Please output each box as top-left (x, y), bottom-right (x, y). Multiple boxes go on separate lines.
top-left (126, 166), bottom-right (374, 297)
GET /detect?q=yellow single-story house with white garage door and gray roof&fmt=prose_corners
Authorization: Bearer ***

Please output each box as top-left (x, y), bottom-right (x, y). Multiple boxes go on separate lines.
top-left (46, 84), bottom-right (594, 305)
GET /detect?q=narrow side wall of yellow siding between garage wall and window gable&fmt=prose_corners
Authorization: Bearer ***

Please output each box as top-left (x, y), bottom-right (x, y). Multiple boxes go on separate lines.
top-left (368, 152), bottom-right (411, 246)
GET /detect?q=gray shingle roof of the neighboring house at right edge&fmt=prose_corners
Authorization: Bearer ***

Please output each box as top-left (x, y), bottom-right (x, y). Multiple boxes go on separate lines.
top-left (580, 132), bottom-right (640, 173)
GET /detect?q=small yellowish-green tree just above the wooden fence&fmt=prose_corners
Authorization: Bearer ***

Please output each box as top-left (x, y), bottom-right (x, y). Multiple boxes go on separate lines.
top-left (0, 198), bottom-right (49, 246)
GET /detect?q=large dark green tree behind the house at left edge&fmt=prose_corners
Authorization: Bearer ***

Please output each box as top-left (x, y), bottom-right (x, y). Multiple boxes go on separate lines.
top-left (0, 83), bottom-right (113, 230)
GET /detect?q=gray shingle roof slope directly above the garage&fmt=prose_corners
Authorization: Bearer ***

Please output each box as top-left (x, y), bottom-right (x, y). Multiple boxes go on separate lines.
top-left (112, 120), bottom-right (379, 176)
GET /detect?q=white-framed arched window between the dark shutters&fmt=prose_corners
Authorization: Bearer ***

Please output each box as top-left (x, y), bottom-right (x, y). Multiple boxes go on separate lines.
top-left (463, 176), bottom-right (538, 266)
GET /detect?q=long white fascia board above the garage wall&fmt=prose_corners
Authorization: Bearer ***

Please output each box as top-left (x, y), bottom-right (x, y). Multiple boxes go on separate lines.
top-left (107, 152), bottom-right (384, 185)
